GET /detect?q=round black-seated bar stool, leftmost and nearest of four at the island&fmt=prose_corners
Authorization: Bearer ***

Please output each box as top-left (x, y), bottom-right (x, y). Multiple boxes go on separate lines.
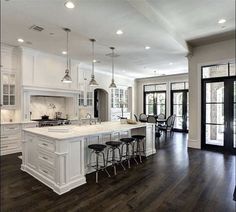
top-left (88, 144), bottom-right (111, 183)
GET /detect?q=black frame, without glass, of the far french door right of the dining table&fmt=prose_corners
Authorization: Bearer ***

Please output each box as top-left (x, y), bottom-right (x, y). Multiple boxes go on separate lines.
top-left (170, 89), bottom-right (189, 133)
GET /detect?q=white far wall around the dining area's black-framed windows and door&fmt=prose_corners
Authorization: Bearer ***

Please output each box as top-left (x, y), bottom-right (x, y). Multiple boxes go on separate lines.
top-left (134, 74), bottom-right (188, 116)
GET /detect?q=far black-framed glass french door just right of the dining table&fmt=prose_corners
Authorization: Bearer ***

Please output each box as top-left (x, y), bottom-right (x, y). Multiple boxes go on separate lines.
top-left (171, 89), bottom-right (189, 132)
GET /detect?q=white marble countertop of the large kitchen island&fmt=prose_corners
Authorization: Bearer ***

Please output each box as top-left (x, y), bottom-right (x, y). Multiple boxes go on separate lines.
top-left (24, 121), bottom-right (148, 140)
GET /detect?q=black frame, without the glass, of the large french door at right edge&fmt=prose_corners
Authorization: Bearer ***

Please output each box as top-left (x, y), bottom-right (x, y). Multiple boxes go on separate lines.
top-left (201, 76), bottom-right (236, 154)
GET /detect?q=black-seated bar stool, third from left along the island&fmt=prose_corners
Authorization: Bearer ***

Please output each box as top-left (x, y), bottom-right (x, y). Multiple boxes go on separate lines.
top-left (120, 138), bottom-right (138, 168)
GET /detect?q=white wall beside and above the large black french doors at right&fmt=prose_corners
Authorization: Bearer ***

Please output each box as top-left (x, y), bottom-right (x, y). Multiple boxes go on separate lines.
top-left (189, 39), bottom-right (235, 148)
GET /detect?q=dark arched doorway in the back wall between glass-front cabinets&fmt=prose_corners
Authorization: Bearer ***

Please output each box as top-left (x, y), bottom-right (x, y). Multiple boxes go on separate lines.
top-left (94, 88), bottom-right (108, 121)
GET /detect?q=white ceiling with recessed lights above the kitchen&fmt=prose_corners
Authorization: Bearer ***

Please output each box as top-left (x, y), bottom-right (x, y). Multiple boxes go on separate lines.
top-left (1, 0), bottom-right (235, 78)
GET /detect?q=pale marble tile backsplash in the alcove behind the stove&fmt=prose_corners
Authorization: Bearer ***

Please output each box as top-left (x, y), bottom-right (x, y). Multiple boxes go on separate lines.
top-left (30, 96), bottom-right (66, 119)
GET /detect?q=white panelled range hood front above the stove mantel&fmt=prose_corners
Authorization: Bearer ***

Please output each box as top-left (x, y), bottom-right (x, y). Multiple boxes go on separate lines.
top-left (22, 48), bottom-right (79, 90)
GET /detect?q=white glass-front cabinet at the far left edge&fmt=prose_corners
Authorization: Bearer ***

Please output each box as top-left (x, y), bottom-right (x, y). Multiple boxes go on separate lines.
top-left (1, 73), bottom-right (16, 107)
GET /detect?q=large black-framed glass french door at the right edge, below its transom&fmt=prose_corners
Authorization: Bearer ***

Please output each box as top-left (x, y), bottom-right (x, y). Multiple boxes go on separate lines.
top-left (202, 77), bottom-right (236, 153)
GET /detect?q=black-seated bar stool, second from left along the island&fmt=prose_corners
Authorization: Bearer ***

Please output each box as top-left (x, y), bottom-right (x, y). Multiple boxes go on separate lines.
top-left (106, 141), bottom-right (125, 175)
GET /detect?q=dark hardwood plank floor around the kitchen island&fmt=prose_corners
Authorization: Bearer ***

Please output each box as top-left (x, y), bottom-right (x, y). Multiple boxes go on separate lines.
top-left (1, 133), bottom-right (236, 212)
